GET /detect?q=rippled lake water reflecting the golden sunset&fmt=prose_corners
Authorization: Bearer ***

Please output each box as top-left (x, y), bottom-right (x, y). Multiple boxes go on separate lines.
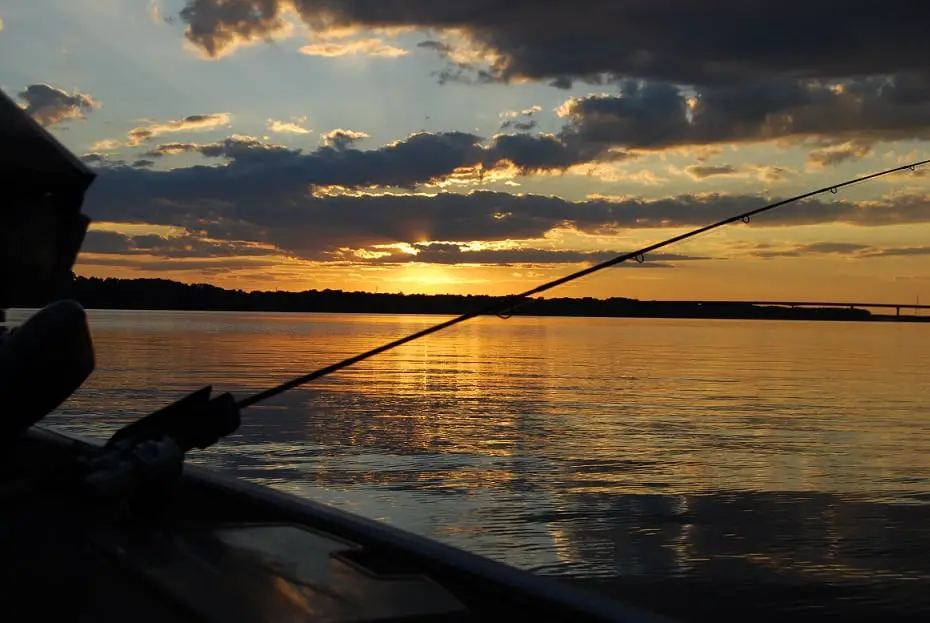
top-left (9, 311), bottom-right (930, 620)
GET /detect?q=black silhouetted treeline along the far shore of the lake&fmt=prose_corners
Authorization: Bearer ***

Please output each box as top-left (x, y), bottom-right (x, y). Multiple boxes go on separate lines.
top-left (11, 276), bottom-right (930, 322)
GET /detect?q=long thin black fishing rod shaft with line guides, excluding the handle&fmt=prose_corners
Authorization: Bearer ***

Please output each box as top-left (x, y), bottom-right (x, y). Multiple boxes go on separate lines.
top-left (236, 160), bottom-right (930, 409)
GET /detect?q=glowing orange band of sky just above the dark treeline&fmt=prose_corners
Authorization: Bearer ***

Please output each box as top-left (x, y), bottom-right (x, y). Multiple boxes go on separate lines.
top-left (77, 218), bottom-right (930, 303)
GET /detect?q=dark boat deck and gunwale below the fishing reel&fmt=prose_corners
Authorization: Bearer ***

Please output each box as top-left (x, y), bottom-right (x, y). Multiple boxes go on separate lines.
top-left (0, 427), bottom-right (667, 623)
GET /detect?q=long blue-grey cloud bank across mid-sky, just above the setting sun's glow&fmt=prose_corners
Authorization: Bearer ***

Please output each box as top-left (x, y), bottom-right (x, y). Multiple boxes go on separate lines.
top-left (78, 143), bottom-right (930, 258)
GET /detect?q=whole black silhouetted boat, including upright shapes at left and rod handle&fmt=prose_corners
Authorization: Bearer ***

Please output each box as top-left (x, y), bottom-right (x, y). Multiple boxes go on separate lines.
top-left (0, 93), bottom-right (676, 623)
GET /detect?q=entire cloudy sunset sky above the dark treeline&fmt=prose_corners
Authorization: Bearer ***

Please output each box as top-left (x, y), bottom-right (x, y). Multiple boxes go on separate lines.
top-left (0, 0), bottom-right (930, 303)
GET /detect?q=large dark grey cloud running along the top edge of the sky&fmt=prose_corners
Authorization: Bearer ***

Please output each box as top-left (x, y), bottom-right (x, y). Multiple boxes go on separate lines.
top-left (174, 0), bottom-right (930, 86)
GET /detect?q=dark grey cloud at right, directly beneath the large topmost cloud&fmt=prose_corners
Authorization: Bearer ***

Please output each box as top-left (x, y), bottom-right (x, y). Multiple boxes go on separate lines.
top-left (559, 73), bottom-right (930, 154)
